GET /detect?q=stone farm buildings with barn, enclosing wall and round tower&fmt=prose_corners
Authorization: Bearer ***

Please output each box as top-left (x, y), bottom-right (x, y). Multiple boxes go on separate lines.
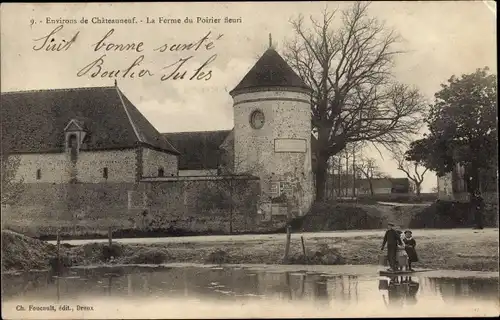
top-left (1, 48), bottom-right (314, 232)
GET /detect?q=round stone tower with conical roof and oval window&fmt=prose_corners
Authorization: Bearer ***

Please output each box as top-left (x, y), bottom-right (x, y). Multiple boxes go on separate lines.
top-left (230, 47), bottom-right (314, 219)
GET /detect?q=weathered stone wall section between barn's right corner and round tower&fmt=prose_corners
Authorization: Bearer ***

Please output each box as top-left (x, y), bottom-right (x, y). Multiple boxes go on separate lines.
top-left (139, 176), bottom-right (260, 232)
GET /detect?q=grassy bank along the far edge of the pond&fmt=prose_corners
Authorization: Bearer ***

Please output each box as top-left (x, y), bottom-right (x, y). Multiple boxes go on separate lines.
top-left (2, 229), bottom-right (498, 271)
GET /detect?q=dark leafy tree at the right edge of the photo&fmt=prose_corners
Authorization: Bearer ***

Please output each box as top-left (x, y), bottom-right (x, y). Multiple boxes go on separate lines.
top-left (406, 67), bottom-right (498, 199)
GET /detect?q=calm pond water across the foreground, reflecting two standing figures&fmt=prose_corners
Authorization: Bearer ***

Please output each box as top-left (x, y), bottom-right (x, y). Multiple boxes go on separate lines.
top-left (2, 265), bottom-right (499, 319)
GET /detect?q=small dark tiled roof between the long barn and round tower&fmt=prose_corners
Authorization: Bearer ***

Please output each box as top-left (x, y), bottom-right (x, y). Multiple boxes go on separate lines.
top-left (163, 130), bottom-right (231, 170)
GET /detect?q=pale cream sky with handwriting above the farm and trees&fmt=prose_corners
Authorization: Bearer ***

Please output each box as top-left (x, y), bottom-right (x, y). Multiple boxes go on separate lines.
top-left (0, 1), bottom-right (496, 192)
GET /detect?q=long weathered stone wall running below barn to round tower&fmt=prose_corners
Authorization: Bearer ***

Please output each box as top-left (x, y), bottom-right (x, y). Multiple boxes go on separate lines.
top-left (2, 177), bottom-right (266, 235)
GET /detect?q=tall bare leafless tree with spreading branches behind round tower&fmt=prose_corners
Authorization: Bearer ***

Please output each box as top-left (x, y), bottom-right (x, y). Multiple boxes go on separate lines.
top-left (285, 2), bottom-right (424, 201)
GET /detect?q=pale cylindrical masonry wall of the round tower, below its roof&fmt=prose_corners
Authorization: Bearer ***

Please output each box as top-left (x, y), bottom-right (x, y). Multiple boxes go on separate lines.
top-left (234, 89), bottom-right (314, 214)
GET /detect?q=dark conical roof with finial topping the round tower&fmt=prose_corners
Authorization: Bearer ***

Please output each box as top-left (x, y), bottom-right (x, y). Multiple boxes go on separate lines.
top-left (229, 48), bottom-right (311, 95)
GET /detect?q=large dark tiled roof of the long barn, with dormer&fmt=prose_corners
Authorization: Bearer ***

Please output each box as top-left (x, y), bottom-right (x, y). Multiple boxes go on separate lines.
top-left (1, 87), bottom-right (178, 154)
